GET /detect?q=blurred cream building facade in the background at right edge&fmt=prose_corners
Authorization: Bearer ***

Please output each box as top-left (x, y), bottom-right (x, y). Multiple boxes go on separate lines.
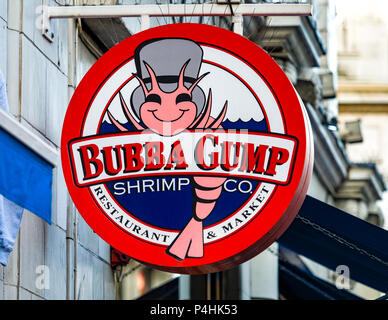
top-left (337, 1), bottom-right (388, 227)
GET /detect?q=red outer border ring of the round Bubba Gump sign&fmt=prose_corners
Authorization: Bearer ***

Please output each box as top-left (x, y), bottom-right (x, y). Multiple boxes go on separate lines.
top-left (61, 24), bottom-right (312, 273)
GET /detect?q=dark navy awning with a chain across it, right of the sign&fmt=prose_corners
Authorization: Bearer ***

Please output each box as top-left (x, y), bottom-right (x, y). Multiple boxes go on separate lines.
top-left (278, 196), bottom-right (388, 292)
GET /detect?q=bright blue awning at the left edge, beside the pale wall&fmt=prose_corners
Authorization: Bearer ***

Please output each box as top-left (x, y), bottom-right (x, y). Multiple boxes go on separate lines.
top-left (0, 128), bottom-right (53, 223)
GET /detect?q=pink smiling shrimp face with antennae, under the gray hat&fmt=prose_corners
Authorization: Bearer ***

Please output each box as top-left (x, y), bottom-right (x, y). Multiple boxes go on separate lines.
top-left (135, 62), bottom-right (206, 136)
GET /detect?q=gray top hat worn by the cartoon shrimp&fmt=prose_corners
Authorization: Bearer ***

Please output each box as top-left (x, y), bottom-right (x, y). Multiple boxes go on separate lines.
top-left (131, 38), bottom-right (205, 116)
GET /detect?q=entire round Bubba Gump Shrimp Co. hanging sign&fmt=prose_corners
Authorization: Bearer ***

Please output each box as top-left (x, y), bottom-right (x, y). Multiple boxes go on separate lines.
top-left (61, 24), bottom-right (313, 274)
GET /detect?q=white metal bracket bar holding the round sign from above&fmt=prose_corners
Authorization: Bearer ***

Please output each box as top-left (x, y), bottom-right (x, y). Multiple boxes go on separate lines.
top-left (42, 2), bottom-right (312, 42)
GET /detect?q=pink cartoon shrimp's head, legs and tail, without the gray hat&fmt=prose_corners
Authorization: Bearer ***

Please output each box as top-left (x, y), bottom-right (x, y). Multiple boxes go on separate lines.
top-left (107, 39), bottom-right (228, 260)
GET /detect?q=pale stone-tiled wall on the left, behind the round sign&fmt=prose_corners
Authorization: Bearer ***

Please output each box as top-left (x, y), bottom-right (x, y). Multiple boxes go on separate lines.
top-left (0, 0), bottom-right (115, 299)
